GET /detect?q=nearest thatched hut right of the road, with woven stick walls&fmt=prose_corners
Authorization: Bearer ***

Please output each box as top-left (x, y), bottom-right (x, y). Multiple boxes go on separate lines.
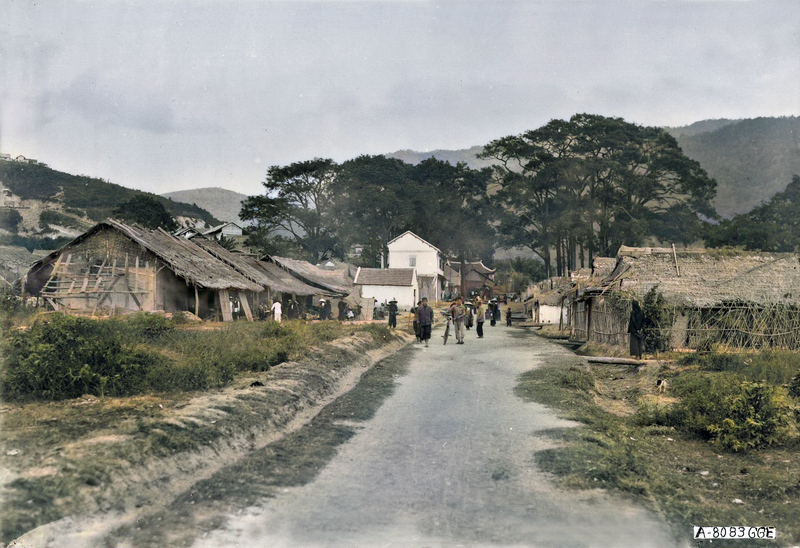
top-left (571, 246), bottom-right (800, 349)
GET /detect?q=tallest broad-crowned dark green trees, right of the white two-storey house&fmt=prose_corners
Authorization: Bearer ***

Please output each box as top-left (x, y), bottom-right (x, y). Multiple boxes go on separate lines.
top-left (481, 114), bottom-right (716, 275)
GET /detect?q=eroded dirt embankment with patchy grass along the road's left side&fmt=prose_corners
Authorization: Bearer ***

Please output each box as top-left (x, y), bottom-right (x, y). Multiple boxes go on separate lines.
top-left (0, 333), bottom-right (410, 547)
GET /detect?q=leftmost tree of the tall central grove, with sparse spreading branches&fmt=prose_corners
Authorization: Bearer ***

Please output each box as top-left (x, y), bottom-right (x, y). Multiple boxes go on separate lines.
top-left (239, 158), bottom-right (344, 262)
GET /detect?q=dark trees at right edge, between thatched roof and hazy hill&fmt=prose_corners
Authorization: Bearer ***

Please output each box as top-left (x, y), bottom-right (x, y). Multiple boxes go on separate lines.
top-left (705, 175), bottom-right (800, 253)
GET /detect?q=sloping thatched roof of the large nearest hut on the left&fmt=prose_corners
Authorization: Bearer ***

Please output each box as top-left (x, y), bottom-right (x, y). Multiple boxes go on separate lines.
top-left (31, 219), bottom-right (264, 291)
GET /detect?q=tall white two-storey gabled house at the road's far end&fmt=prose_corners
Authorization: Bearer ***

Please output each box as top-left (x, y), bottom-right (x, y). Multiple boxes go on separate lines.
top-left (386, 231), bottom-right (445, 303)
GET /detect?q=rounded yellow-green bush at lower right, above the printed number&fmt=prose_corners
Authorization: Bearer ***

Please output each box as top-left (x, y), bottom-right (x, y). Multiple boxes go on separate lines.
top-left (667, 373), bottom-right (793, 451)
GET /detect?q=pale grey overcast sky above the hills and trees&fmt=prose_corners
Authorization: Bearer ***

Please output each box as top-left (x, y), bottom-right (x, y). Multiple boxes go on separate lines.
top-left (0, 0), bottom-right (800, 194)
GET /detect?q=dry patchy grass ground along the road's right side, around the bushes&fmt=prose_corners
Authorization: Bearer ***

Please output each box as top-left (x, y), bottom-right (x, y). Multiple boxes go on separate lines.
top-left (518, 348), bottom-right (800, 547)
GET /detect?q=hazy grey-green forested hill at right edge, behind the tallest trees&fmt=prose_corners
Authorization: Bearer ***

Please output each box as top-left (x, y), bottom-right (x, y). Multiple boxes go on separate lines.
top-left (669, 116), bottom-right (800, 217)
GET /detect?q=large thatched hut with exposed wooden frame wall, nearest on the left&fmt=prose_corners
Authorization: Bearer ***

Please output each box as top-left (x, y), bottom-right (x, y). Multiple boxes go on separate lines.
top-left (25, 219), bottom-right (264, 321)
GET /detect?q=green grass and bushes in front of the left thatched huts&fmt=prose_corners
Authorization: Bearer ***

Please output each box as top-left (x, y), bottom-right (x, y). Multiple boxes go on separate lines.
top-left (0, 312), bottom-right (391, 401)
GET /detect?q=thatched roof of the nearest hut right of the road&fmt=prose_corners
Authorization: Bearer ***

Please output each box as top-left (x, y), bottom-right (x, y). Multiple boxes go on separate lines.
top-left (593, 246), bottom-right (800, 307)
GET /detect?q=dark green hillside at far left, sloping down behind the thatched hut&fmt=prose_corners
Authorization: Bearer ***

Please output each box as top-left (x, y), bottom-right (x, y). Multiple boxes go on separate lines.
top-left (0, 161), bottom-right (216, 225)
